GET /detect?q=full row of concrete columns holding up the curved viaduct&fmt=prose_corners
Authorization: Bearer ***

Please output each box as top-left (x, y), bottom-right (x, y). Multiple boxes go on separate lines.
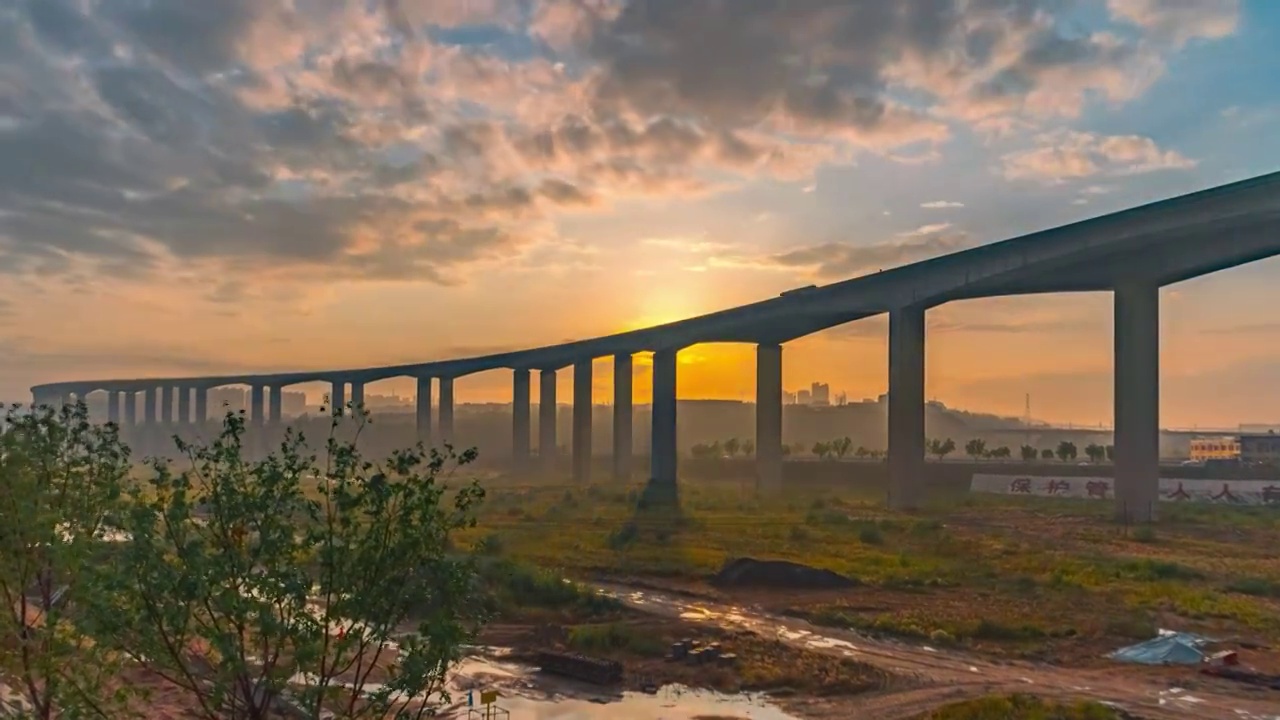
top-left (36, 282), bottom-right (1160, 521)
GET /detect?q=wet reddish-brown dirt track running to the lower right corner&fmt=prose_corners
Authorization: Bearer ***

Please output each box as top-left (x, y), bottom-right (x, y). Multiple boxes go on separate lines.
top-left (596, 583), bottom-right (1280, 720)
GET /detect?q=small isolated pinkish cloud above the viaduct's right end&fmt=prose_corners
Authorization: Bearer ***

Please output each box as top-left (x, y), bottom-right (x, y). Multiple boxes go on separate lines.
top-left (1001, 131), bottom-right (1196, 180)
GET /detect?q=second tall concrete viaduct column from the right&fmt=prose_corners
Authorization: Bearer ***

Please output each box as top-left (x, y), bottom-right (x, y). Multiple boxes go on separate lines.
top-left (888, 307), bottom-right (924, 510)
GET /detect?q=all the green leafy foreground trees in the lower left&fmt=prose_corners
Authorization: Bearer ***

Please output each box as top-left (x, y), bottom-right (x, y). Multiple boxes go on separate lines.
top-left (0, 406), bottom-right (485, 720)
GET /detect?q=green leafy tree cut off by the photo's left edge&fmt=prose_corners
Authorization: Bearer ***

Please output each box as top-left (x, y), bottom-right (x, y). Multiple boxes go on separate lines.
top-left (0, 402), bottom-right (129, 719)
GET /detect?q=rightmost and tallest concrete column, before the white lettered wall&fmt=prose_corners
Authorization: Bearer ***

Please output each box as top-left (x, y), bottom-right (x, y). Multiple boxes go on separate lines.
top-left (1115, 282), bottom-right (1160, 523)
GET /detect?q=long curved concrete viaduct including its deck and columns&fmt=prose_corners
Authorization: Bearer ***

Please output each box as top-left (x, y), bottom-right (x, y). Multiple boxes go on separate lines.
top-left (32, 172), bottom-right (1280, 521)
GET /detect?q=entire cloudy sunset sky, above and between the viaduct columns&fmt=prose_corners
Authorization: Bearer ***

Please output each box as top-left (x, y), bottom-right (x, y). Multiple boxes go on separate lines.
top-left (0, 0), bottom-right (1280, 427)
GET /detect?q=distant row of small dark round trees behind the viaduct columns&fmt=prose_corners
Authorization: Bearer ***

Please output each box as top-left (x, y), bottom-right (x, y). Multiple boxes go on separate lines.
top-left (690, 437), bottom-right (1115, 462)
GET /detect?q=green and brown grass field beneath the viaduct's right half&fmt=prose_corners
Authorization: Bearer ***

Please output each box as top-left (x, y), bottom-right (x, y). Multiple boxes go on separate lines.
top-left (461, 478), bottom-right (1280, 657)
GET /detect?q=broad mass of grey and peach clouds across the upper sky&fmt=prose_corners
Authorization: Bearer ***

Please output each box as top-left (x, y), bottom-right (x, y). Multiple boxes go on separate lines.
top-left (0, 0), bottom-right (1234, 297)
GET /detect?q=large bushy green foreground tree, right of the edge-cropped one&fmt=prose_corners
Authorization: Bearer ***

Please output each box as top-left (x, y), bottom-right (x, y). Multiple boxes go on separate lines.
top-left (82, 413), bottom-right (484, 720)
